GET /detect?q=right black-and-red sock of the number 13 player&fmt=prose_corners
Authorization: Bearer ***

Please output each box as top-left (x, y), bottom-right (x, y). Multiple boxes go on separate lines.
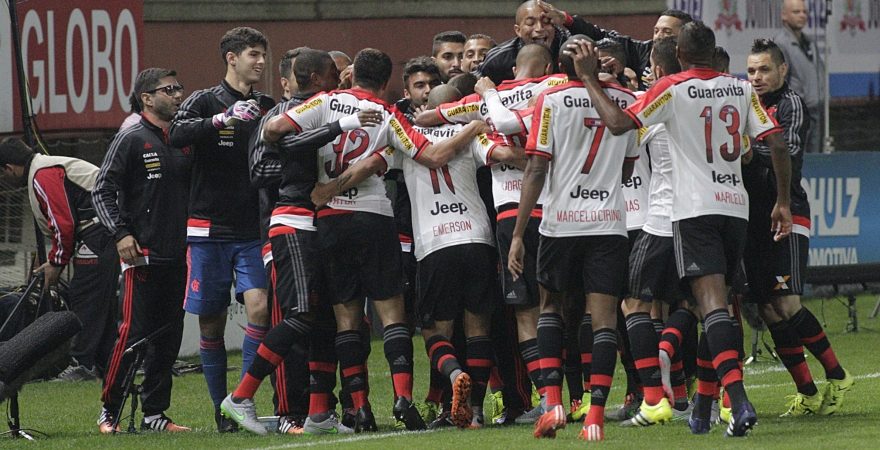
top-left (705, 308), bottom-right (748, 405)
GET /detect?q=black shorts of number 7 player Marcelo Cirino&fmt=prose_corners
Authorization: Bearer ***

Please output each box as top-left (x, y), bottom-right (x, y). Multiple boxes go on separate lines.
top-left (538, 235), bottom-right (629, 297)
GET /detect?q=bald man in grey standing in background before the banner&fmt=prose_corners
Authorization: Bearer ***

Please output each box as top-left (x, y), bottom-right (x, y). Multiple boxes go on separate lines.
top-left (773, 0), bottom-right (825, 153)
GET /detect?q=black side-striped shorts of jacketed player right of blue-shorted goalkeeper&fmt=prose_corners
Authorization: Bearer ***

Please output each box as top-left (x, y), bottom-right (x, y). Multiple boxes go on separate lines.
top-left (269, 227), bottom-right (321, 313)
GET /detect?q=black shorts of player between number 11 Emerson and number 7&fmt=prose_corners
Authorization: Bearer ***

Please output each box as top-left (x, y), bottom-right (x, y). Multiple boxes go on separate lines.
top-left (495, 217), bottom-right (541, 306)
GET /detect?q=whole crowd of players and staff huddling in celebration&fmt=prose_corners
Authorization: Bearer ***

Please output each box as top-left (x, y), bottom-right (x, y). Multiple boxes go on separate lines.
top-left (93, 1), bottom-right (853, 440)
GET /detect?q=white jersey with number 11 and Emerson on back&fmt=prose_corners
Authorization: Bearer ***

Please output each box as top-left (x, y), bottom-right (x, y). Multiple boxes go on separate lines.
top-left (384, 124), bottom-right (496, 261)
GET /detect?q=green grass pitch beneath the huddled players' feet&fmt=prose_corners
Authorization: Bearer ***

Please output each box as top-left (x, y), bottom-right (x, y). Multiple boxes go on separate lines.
top-left (6, 296), bottom-right (880, 450)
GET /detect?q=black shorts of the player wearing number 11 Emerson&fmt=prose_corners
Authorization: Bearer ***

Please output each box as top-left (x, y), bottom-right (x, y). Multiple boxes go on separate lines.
top-left (416, 244), bottom-right (497, 327)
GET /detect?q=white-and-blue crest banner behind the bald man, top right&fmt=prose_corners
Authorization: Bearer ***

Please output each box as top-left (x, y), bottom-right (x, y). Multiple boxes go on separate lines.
top-left (666, 0), bottom-right (880, 97)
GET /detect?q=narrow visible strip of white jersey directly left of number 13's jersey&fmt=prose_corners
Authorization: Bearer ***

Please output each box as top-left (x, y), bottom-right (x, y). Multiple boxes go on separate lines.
top-left (639, 124), bottom-right (672, 237)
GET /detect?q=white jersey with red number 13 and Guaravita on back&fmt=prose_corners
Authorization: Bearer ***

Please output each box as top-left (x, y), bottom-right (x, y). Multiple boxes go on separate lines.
top-left (627, 68), bottom-right (781, 222)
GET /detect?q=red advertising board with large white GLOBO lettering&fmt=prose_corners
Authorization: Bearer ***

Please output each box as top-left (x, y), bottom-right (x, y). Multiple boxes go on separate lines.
top-left (0, 0), bottom-right (144, 133)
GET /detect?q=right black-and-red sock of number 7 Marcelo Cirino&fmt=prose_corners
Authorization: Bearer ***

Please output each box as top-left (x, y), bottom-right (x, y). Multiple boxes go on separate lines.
top-left (584, 328), bottom-right (617, 425)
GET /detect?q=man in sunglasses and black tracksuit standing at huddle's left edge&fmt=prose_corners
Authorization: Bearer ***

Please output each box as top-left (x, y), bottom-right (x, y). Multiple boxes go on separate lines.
top-left (92, 68), bottom-right (190, 433)
